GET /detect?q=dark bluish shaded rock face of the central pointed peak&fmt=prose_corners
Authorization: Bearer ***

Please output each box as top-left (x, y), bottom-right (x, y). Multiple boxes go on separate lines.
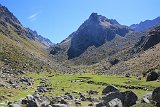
top-left (67, 13), bottom-right (130, 59)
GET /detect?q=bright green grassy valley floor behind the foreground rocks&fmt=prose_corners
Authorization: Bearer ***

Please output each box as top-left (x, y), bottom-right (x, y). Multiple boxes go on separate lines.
top-left (0, 72), bottom-right (160, 106)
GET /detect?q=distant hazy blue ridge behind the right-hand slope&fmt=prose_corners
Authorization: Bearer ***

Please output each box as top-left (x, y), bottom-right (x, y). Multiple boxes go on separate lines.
top-left (130, 17), bottom-right (160, 32)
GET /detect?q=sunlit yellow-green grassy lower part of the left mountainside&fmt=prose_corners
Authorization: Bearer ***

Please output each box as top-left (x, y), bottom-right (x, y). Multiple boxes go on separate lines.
top-left (0, 30), bottom-right (52, 70)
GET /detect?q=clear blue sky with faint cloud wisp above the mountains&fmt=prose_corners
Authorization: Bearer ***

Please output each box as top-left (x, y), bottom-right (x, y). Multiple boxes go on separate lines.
top-left (0, 0), bottom-right (160, 43)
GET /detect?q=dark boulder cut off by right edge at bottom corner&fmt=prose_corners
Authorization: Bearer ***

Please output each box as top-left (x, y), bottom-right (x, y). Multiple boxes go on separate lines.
top-left (152, 87), bottom-right (160, 104)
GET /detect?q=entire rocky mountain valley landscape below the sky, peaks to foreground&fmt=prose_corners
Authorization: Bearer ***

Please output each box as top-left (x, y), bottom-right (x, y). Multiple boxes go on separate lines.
top-left (0, 2), bottom-right (160, 107)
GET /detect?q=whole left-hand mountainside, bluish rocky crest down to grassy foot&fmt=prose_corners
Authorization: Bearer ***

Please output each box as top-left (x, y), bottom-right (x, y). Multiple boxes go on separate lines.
top-left (0, 5), bottom-right (51, 73)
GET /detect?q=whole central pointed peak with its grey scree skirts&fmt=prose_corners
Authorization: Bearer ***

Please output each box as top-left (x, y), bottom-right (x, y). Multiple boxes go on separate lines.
top-left (50, 13), bottom-right (138, 64)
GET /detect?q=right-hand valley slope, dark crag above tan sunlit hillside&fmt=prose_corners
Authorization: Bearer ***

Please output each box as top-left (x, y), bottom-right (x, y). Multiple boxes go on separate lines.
top-left (99, 25), bottom-right (160, 75)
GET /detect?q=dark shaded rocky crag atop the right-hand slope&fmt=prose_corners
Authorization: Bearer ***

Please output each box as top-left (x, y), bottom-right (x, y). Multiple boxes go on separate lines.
top-left (134, 25), bottom-right (160, 53)
